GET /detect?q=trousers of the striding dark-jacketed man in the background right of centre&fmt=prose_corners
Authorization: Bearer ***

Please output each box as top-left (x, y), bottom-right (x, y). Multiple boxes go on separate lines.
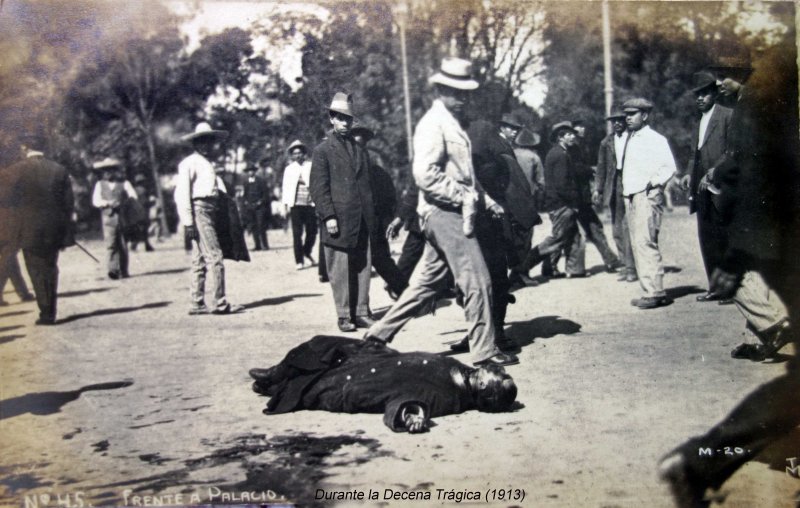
top-left (521, 206), bottom-right (586, 275)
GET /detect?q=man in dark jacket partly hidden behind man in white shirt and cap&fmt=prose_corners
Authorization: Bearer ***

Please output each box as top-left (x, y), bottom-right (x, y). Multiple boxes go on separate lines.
top-left (592, 111), bottom-right (638, 282)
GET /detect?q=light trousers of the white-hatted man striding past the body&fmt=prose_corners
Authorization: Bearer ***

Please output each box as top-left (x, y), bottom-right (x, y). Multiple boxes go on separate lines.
top-left (367, 209), bottom-right (500, 362)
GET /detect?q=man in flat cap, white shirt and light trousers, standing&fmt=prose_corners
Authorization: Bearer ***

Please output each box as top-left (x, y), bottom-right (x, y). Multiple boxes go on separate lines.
top-left (622, 98), bottom-right (676, 309)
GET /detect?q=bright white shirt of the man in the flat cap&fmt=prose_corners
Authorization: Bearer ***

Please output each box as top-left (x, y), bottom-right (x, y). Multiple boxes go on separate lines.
top-left (622, 125), bottom-right (677, 196)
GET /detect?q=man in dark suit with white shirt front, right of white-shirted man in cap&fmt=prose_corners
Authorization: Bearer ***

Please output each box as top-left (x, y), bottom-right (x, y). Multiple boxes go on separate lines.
top-left (683, 72), bottom-right (732, 302)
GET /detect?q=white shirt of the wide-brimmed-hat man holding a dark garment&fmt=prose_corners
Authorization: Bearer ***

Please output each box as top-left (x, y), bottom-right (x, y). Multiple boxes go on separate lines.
top-left (175, 152), bottom-right (225, 226)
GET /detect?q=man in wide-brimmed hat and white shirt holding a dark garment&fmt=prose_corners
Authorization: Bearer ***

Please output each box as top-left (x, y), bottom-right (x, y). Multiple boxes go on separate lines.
top-left (175, 122), bottom-right (244, 315)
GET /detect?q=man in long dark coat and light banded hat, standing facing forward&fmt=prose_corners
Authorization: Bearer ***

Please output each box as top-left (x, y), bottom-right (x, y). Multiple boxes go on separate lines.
top-left (309, 92), bottom-right (375, 332)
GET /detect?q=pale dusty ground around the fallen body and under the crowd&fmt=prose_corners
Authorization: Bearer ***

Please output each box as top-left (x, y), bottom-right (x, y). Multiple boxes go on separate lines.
top-left (0, 209), bottom-right (800, 508)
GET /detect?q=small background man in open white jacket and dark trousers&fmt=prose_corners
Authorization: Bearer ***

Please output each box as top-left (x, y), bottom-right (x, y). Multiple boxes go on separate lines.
top-left (281, 139), bottom-right (322, 270)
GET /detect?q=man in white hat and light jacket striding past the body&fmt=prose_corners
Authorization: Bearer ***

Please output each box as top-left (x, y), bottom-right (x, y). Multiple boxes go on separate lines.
top-left (364, 58), bottom-right (519, 365)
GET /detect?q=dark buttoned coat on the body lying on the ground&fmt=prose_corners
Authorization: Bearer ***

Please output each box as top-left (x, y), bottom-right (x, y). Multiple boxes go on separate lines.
top-left (260, 335), bottom-right (475, 431)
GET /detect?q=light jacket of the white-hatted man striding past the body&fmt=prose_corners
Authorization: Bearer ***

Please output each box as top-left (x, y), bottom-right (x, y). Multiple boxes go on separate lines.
top-left (412, 99), bottom-right (492, 220)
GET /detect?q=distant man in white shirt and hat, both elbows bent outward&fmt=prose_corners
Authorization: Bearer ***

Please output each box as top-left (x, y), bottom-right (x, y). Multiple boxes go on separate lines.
top-left (92, 157), bottom-right (138, 280)
